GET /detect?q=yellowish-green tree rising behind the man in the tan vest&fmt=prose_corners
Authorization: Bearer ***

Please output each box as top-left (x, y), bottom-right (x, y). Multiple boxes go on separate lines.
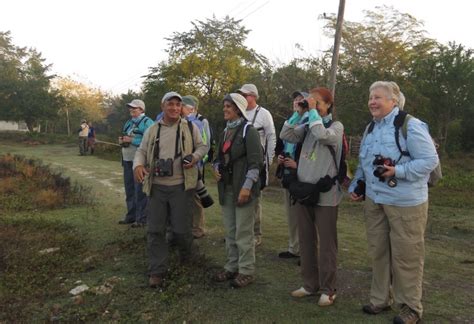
top-left (144, 17), bottom-right (267, 130)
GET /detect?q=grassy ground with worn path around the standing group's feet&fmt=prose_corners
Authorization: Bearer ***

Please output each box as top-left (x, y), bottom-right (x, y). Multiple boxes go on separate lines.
top-left (0, 142), bottom-right (474, 323)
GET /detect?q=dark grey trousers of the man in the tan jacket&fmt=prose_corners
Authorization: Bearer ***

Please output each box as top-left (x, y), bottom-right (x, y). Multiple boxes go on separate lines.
top-left (147, 184), bottom-right (195, 275)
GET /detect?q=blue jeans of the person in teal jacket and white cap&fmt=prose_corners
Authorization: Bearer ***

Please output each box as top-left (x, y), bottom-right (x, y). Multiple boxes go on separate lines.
top-left (122, 160), bottom-right (148, 224)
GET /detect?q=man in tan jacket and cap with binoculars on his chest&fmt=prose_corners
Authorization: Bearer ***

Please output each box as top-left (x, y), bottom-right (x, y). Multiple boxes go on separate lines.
top-left (133, 92), bottom-right (207, 287)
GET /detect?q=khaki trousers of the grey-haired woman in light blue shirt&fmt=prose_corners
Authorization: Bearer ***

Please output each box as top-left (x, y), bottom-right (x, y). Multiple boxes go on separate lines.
top-left (364, 198), bottom-right (428, 317)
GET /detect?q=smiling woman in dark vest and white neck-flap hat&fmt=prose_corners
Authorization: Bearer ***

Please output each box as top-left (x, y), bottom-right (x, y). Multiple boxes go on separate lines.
top-left (214, 93), bottom-right (263, 288)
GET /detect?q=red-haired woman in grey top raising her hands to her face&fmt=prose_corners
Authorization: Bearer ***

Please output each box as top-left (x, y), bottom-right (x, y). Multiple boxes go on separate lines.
top-left (280, 87), bottom-right (344, 306)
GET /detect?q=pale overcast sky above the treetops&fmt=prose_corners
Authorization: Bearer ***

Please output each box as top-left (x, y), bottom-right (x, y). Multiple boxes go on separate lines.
top-left (0, 0), bottom-right (474, 94)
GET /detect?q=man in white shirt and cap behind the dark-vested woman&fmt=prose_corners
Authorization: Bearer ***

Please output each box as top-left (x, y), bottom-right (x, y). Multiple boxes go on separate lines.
top-left (237, 83), bottom-right (276, 246)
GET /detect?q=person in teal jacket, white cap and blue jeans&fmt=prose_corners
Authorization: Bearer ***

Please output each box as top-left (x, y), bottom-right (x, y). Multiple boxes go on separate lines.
top-left (119, 99), bottom-right (153, 227)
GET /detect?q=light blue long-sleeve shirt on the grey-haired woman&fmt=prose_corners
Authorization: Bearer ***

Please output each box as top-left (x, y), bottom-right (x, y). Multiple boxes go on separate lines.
top-left (349, 107), bottom-right (439, 206)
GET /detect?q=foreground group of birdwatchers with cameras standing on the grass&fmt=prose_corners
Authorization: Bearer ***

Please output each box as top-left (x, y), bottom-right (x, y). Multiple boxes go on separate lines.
top-left (116, 81), bottom-right (438, 323)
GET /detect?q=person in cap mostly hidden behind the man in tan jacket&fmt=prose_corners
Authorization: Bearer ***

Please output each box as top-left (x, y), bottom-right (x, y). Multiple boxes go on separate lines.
top-left (182, 96), bottom-right (214, 239)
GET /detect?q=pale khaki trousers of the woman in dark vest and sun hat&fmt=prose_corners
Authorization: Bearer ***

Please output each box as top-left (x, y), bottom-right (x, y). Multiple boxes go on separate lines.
top-left (222, 186), bottom-right (256, 275)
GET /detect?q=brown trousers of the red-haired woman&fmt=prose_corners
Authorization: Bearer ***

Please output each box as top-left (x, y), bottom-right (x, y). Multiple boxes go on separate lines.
top-left (294, 202), bottom-right (338, 295)
